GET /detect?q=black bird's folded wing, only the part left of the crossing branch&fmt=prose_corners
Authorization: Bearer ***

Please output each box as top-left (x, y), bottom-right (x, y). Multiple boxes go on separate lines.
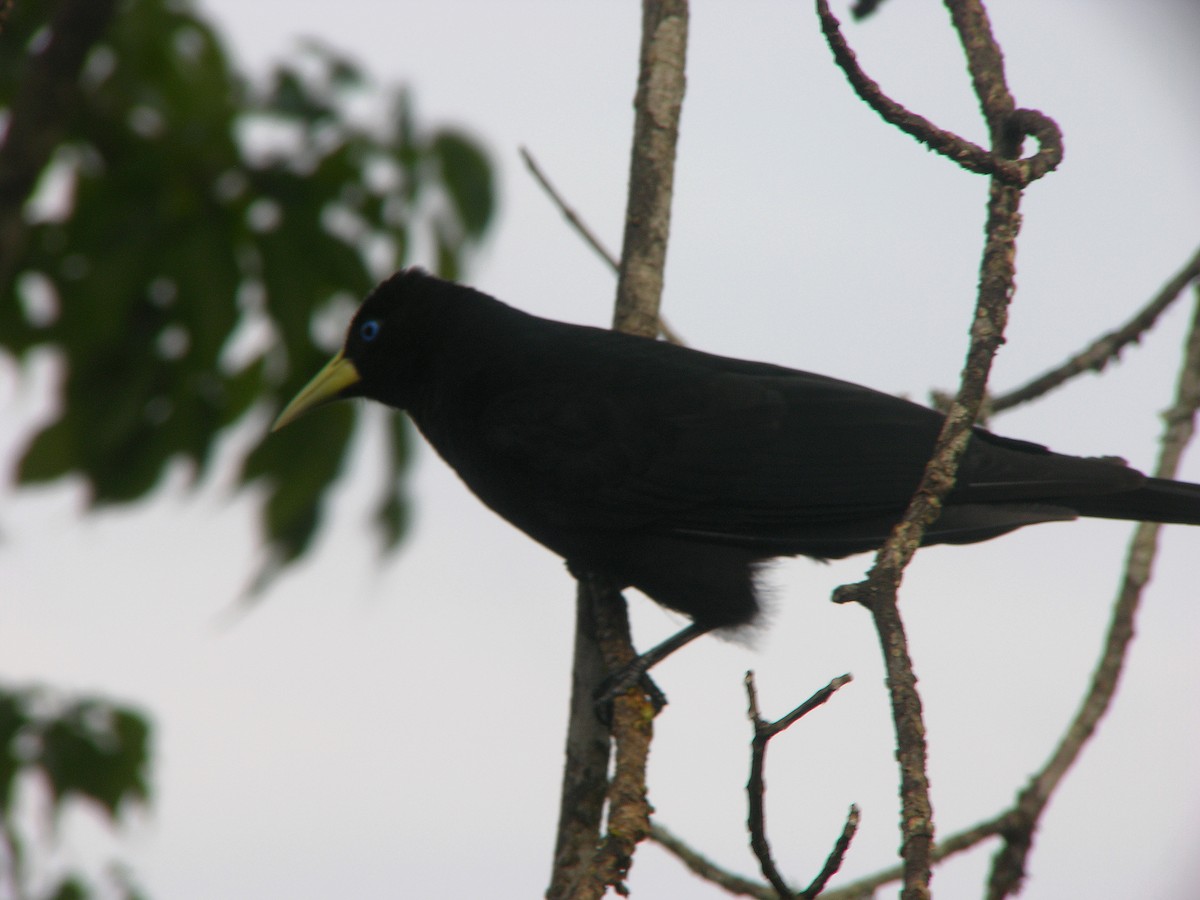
top-left (470, 354), bottom-right (941, 533)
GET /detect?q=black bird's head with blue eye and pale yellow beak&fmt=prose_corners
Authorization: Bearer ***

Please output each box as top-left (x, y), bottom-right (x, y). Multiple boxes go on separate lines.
top-left (271, 269), bottom-right (454, 431)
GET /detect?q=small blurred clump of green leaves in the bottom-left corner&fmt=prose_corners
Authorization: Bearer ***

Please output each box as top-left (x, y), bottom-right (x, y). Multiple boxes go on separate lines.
top-left (0, 688), bottom-right (150, 900)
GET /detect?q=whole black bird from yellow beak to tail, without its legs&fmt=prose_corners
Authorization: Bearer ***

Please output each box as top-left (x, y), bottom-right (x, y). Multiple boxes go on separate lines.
top-left (280, 269), bottom-right (1200, 628)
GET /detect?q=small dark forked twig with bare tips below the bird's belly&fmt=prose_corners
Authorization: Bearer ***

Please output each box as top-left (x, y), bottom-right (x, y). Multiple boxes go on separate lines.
top-left (745, 672), bottom-right (858, 900)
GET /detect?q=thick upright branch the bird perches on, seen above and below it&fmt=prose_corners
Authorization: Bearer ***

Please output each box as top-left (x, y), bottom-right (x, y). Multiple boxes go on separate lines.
top-left (547, 0), bottom-right (688, 900)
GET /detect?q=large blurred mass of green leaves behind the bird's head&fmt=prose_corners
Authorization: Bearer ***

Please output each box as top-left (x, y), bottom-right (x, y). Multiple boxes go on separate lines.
top-left (0, 0), bottom-right (493, 575)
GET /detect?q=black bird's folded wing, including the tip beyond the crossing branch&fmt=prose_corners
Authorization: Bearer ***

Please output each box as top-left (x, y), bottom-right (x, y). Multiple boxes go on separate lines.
top-left (472, 354), bottom-right (1141, 556)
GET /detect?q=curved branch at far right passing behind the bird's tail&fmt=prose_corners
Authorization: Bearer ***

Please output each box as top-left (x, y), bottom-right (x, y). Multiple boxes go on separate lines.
top-left (988, 287), bottom-right (1200, 900)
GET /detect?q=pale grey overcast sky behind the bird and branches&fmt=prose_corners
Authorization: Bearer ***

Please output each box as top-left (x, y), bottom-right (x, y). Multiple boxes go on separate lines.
top-left (0, 0), bottom-right (1200, 900)
